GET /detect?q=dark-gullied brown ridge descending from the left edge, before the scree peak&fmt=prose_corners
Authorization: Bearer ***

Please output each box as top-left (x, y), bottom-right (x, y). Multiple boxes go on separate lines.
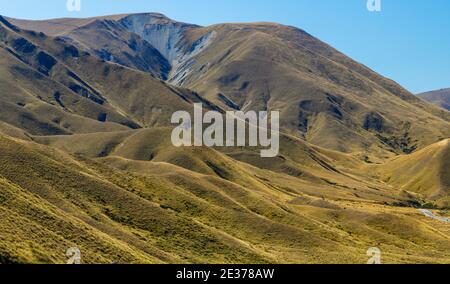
top-left (0, 15), bottom-right (217, 135)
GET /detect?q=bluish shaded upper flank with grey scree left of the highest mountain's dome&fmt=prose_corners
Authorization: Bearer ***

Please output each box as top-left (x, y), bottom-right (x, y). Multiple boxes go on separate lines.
top-left (8, 13), bottom-right (198, 80)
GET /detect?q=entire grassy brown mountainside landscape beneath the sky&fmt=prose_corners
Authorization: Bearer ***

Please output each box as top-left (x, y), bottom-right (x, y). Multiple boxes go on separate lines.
top-left (0, 13), bottom-right (450, 263)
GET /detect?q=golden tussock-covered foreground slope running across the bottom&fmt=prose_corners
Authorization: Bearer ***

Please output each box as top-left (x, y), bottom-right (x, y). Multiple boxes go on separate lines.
top-left (0, 132), bottom-right (450, 263)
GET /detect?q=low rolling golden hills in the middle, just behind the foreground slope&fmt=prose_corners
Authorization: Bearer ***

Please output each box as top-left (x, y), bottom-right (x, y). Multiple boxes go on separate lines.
top-left (32, 128), bottom-right (428, 204)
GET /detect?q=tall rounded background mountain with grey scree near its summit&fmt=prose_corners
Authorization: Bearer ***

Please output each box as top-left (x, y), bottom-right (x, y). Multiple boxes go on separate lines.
top-left (7, 13), bottom-right (450, 161)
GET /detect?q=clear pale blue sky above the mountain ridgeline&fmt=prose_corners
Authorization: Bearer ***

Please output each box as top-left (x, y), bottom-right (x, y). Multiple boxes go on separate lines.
top-left (0, 0), bottom-right (450, 93)
